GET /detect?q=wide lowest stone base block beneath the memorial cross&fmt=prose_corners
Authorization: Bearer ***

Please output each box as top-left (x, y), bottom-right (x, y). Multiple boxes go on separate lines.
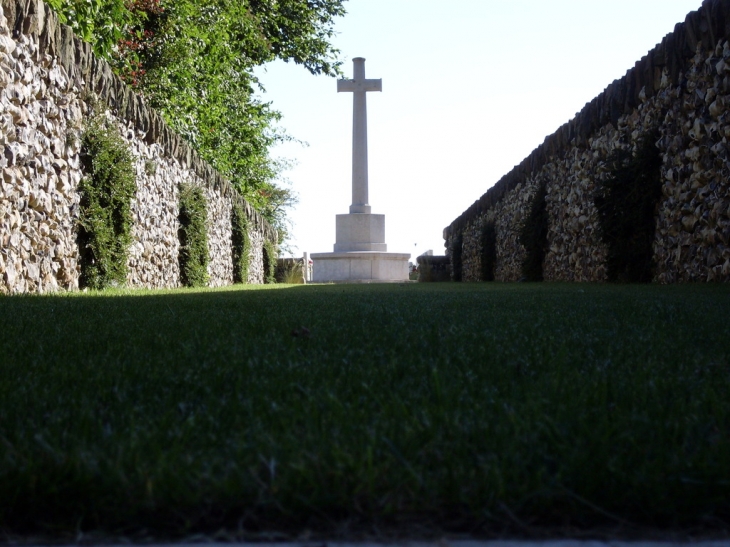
top-left (310, 251), bottom-right (411, 283)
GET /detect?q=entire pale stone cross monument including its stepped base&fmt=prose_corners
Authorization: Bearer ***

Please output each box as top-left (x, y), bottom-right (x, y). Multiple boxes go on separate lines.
top-left (311, 57), bottom-right (411, 283)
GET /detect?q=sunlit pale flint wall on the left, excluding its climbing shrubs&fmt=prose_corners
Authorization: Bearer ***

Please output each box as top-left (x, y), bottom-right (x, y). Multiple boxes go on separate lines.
top-left (0, 0), bottom-right (276, 293)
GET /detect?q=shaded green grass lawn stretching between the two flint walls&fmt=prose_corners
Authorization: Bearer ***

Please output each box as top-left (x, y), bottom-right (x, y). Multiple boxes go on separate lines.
top-left (0, 283), bottom-right (730, 539)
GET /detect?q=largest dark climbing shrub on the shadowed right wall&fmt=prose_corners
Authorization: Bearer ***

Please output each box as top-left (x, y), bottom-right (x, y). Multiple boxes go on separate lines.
top-left (594, 131), bottom-right (662, 283)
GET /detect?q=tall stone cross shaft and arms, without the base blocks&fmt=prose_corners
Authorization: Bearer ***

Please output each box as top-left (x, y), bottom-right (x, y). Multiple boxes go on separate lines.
top-left (337, 57), bottom-right (383, 213)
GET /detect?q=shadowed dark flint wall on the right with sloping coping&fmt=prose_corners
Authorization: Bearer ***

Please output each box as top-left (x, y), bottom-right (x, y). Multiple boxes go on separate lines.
top-left (444, 0), bottom-right (730, 283)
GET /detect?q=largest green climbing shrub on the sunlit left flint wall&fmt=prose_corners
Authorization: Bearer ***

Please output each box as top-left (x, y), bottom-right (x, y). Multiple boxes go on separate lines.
top-left (77, 117), bottom-right (137, 289)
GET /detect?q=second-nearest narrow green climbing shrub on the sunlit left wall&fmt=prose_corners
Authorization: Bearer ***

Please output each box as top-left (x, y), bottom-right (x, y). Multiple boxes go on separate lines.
top-left (178, 184), bottom-right (209, 287)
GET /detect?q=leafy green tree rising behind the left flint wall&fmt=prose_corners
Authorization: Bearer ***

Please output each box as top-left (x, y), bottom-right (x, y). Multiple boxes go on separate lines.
top-left (51, 0), bottom-right (345, 246)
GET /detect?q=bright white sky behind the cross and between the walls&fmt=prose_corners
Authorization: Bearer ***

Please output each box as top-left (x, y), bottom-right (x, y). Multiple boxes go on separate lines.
top-left (258, 0), bottom-right (701, 262)
